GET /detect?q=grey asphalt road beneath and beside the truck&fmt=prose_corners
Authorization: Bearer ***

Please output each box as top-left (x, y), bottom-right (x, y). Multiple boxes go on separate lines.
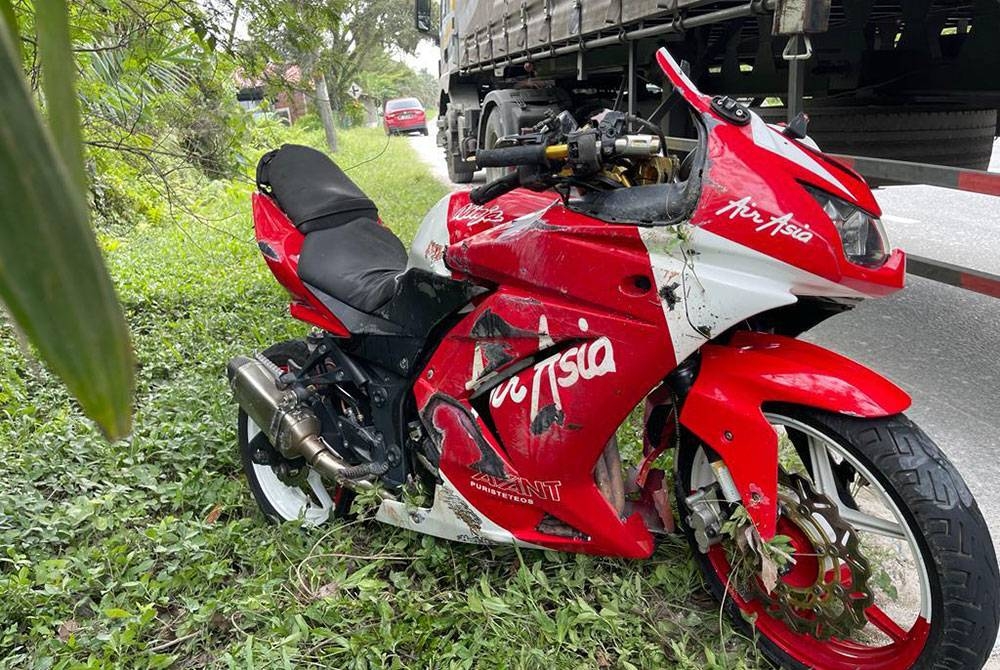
top-left (410, 137), bottom-right (1000, 670)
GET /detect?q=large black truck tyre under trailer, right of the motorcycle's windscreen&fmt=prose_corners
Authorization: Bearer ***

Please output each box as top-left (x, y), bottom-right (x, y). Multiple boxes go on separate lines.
top-left (757, 107), bottom-right (997, 170)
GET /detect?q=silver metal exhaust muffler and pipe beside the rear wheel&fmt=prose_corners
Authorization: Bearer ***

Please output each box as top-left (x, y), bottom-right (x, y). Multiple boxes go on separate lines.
top-left (226, 356), bottom-right (391, 497)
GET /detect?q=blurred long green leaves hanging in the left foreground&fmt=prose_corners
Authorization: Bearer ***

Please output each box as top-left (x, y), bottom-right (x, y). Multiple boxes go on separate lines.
top-left (0, 11), bottom-right (135, 439)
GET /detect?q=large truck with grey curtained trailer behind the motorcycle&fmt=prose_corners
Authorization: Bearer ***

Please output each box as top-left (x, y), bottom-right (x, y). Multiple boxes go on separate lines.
top-left (416, 0), bottom-right (1000, 183)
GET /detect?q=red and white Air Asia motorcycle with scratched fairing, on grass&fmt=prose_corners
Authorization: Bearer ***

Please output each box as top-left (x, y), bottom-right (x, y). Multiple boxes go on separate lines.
top-left (228, 50), bottom-right (1000, 670)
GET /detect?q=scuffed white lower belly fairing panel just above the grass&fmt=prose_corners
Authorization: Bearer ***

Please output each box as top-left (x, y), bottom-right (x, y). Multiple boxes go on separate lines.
top-left (375, 473), bottom-right (541, 549)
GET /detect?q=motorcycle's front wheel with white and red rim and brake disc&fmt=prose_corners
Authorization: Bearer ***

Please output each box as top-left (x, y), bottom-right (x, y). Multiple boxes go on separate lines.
top-left (677, 407), bottom-right (1000, 670)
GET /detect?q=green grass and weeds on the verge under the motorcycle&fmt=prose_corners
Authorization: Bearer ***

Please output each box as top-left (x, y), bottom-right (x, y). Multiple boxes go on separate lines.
top-left (0, 123), bottom-right (759, 669)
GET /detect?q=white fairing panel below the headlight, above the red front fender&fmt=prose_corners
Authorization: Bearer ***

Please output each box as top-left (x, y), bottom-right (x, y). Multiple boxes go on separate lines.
top-left (639, 226), bottom-right (864, 362)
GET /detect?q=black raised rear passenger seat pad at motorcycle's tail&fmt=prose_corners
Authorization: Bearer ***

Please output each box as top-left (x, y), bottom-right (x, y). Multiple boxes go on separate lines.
top-left (257, 144), bottom-right (378, 233)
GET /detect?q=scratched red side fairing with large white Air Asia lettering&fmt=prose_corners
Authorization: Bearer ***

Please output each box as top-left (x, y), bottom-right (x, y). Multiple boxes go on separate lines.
top-left (415, 272), bottom-right (674, 557)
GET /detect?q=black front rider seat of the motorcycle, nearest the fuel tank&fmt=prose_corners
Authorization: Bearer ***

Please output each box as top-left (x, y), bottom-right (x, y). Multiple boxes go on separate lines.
top-left (299, 218), bottom-right (406, 313)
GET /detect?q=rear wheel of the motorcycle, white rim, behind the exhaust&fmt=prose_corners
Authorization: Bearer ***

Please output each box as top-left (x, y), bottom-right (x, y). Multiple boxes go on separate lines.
top-left (237, 340), bottom-right (354, 526)
